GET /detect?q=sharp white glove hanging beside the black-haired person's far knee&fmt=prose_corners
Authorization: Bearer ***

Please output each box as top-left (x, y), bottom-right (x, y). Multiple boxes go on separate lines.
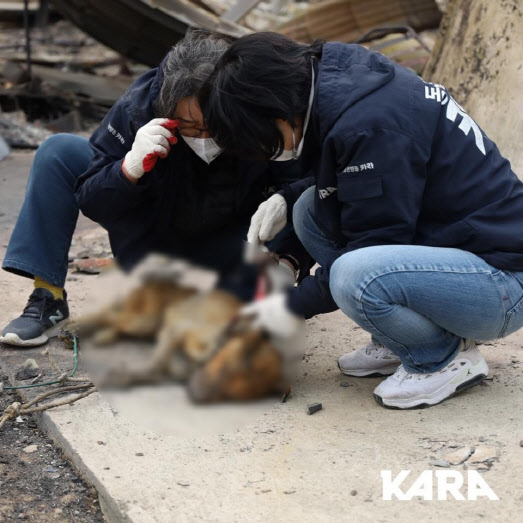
top-left (247, 194), bottom-right (287, 245)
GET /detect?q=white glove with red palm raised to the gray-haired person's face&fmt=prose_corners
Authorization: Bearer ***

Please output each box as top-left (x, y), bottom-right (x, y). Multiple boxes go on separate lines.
top-left (124, 118), bottom-right (178, 180)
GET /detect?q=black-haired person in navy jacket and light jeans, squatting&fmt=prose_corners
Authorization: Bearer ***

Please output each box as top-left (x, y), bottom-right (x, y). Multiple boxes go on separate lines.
top-left (199, 33), bottom-right (523, 408)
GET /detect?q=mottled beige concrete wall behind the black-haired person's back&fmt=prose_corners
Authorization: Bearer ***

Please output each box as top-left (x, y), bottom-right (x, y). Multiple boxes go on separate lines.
top-left (423, 0), bottom-right (523, 179)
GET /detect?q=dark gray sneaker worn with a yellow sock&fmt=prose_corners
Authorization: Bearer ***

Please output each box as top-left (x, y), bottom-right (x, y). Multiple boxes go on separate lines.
top-left (0, 289), bottom-right (69, 347)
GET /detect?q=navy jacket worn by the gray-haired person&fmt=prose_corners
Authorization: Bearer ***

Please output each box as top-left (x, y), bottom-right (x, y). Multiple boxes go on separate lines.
top-left (75, 66), bottom-right (297, 268)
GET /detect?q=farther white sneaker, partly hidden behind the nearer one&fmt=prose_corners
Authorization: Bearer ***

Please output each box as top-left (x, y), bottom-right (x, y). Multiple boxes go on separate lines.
top-left (338, 342), bottom-right (401, 377)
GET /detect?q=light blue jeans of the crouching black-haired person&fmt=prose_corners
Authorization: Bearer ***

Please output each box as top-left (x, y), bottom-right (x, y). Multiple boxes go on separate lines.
top-left (293, 187), bottom-right (523, 373)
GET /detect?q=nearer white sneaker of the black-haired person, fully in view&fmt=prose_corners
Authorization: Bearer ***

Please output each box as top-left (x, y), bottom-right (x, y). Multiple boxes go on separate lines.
top-left (374, 340), bottom-right (488, 409)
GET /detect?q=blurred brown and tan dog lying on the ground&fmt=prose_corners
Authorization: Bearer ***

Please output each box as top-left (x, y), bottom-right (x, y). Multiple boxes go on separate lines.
top-left (80, 261), bottom-right (288, 403)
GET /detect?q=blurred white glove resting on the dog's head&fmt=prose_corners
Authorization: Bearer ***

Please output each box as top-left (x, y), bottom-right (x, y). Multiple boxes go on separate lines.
top-left (240, 293), bottom-right (303, 338)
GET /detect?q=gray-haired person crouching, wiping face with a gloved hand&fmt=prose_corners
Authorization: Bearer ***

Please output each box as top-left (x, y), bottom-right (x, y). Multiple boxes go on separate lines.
top-left (0, 31), bottom-right (310, 346)
